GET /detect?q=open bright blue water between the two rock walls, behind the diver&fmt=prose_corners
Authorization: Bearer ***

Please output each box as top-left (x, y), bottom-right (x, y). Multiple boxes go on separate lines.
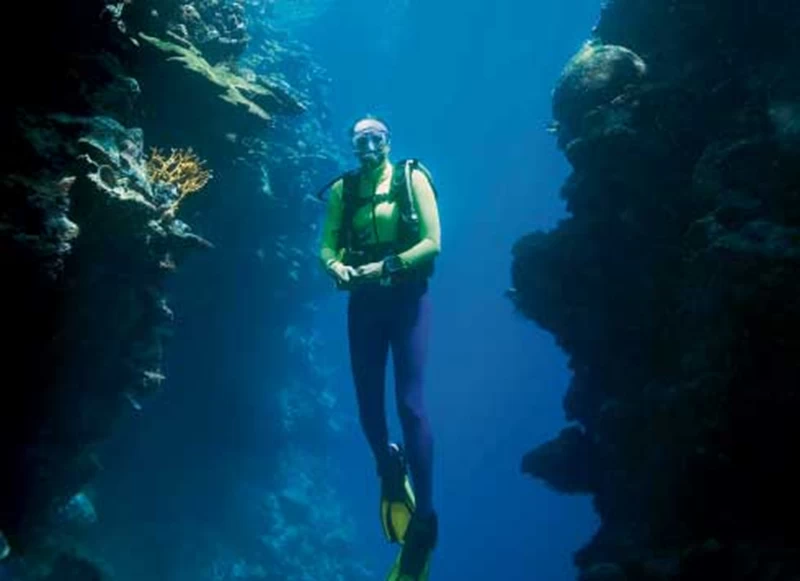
top-left (301, 0), bottom-right (600, 581)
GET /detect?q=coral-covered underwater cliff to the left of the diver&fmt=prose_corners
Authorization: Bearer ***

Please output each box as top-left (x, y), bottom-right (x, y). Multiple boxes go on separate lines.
top-left (0, 0), bottom-right (364, 581)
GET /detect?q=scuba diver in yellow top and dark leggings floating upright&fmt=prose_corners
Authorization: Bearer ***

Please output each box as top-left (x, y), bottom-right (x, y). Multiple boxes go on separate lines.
top-left (320, 116), bottom-right (441, 581)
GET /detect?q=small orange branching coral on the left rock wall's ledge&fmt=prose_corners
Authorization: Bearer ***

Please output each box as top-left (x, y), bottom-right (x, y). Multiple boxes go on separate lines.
top-left (147, 147), bottom-right (212, 217)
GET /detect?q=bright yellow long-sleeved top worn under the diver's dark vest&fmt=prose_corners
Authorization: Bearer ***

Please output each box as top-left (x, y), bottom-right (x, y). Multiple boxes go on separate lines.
top-left (320, 161), bottom-right (441, 268)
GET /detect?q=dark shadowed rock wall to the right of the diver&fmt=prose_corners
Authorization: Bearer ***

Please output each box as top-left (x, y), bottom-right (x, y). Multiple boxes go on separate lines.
top-left (511, 0), bottom-right (800, 581)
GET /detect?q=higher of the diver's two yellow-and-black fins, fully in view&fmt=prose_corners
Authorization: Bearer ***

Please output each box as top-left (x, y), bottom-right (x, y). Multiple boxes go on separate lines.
top-left (380, 444), bottom-right (416, 544)
